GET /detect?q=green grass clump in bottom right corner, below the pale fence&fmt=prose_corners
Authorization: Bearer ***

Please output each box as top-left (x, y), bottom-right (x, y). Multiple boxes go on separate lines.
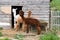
top-left (39, 28), bottom-right (60, 40)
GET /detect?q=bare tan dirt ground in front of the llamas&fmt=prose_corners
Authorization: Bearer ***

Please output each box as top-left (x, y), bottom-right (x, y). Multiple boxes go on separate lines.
top-left (1, 29), bottom-right (39, 40)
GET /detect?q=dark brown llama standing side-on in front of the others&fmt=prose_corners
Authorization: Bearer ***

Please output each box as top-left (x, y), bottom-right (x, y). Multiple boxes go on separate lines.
top-left (19, 10), bottom-right (41, 34)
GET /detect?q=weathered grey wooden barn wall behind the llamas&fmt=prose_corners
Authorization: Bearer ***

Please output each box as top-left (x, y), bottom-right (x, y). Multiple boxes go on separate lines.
top-left (0, 0), bottom-right (50, 29)
